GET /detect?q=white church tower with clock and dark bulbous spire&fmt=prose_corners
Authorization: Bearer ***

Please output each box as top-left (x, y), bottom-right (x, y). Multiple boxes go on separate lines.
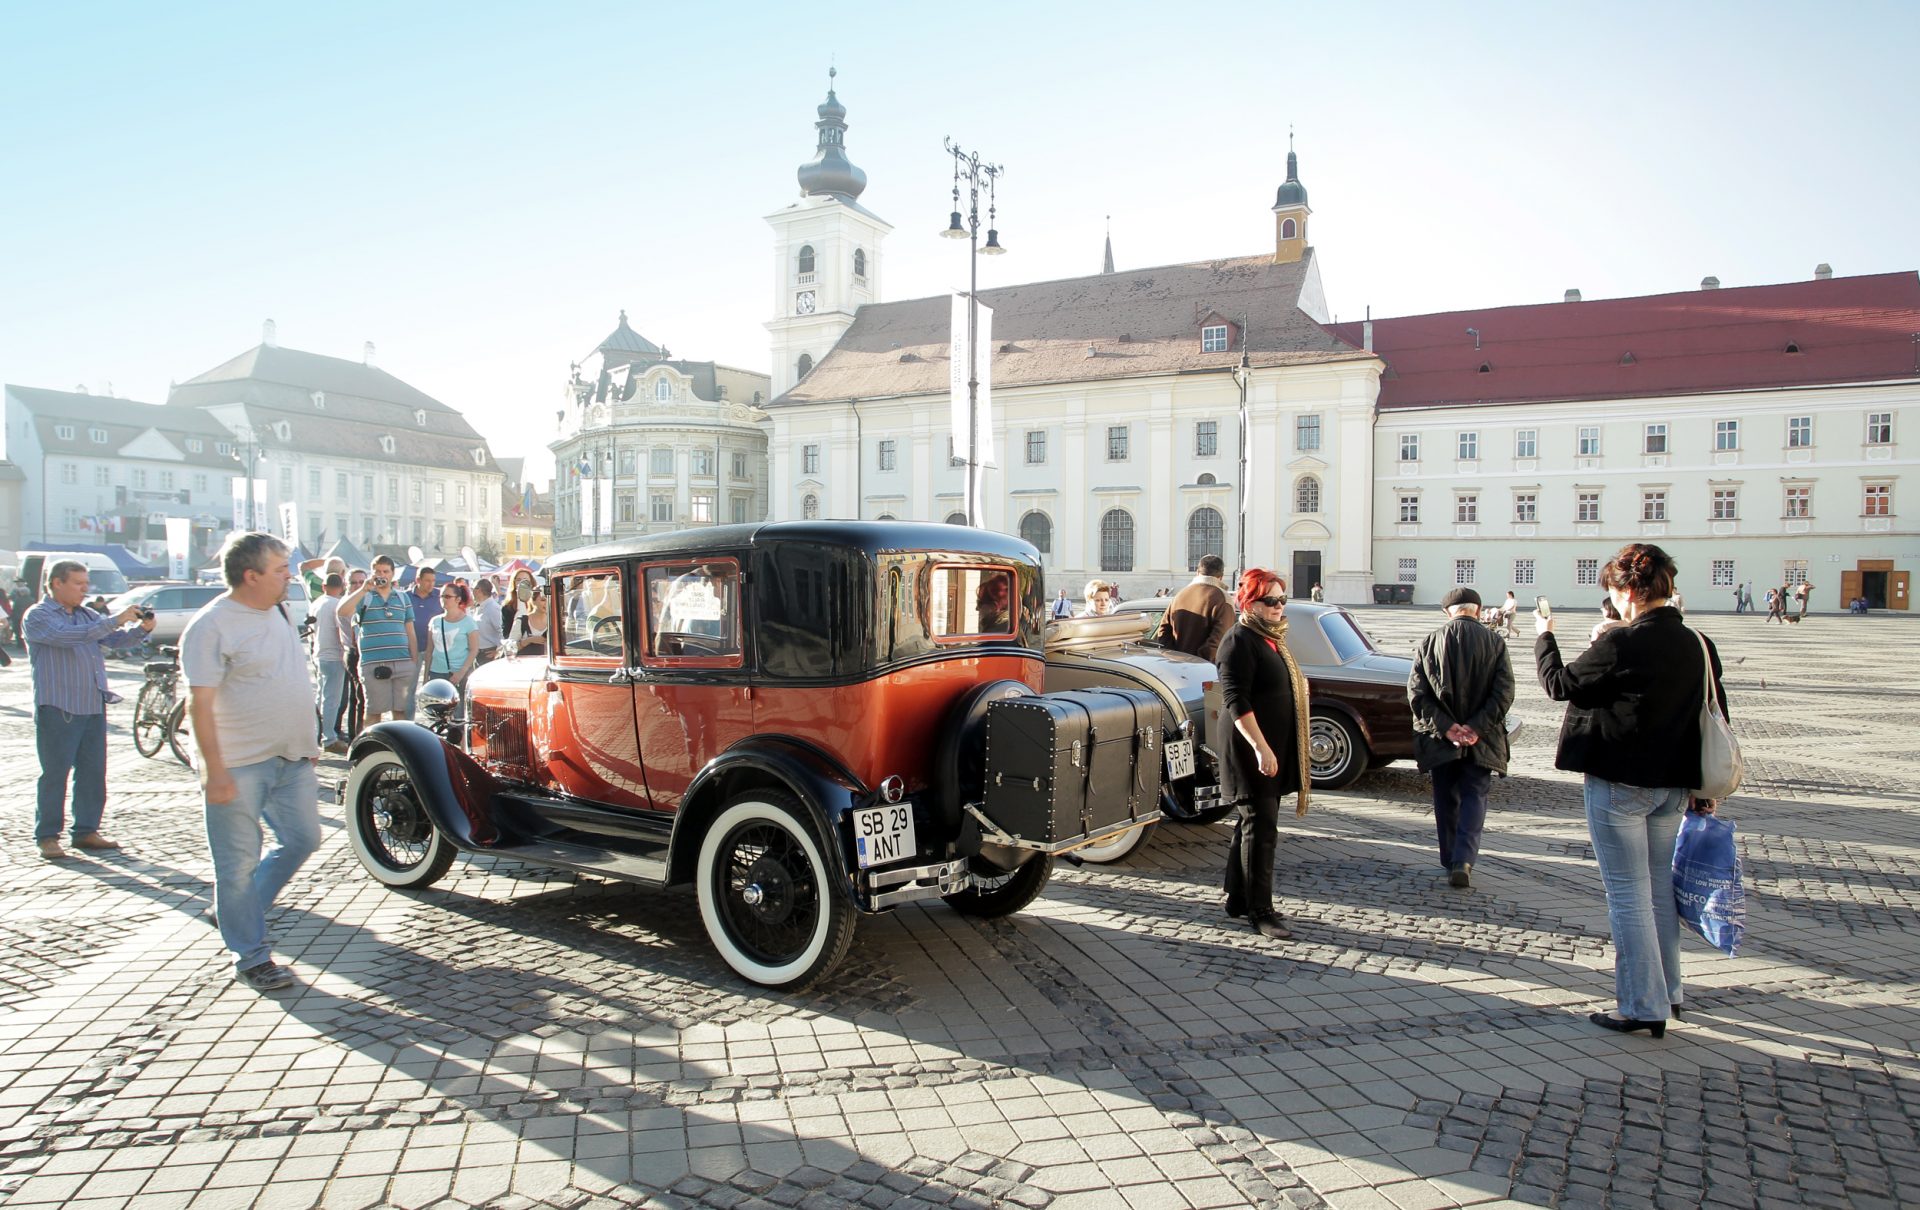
top-left (766, 71), bottom-right (893, 398)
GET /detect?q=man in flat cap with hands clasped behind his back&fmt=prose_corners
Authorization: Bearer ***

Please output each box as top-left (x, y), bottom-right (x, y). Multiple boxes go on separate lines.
top-left (1407, 588), bottom-right (1513, 887)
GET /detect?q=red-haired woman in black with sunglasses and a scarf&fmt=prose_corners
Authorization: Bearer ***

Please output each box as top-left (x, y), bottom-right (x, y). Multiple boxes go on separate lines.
top-left (1213, 567), bottom-right (1313, 939)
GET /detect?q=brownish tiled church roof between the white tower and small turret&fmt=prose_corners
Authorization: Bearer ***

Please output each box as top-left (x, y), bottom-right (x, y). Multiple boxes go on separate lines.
top-left (770, 250), bottom-right (1371, 407)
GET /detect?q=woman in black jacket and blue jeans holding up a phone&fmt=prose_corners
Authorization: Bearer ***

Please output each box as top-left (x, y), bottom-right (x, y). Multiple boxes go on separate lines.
top-left (1534, 542), bottom-right (1726, 1037)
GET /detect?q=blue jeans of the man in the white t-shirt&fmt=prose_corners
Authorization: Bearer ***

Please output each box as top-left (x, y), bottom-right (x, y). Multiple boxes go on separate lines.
top-left (205, 757), bottom-right (321, 970)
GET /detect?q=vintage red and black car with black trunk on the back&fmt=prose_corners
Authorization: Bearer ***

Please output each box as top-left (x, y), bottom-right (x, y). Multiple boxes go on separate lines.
top-left (342, 522), bottom-right (1159, 987)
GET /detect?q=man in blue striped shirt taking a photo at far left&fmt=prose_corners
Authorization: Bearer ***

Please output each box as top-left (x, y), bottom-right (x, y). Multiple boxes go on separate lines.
top-left (23, 559), bottom-right (154, 860)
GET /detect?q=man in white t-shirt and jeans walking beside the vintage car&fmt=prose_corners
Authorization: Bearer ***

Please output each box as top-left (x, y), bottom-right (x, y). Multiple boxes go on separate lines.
top-left (180, 534), bottom-right (321, 991)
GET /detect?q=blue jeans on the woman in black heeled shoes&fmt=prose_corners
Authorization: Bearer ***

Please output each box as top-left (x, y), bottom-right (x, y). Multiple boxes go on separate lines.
top-left (1586, 774), bottom-right (1692, 1022)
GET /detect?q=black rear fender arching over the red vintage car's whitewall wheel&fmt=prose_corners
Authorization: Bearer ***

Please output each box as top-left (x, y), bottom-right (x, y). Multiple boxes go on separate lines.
top-left (666, 736), bottom-right (872, 901)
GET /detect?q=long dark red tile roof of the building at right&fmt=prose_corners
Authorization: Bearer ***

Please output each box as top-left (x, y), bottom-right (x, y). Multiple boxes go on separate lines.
top-left (1331, 273), bottom-right (1920, 409)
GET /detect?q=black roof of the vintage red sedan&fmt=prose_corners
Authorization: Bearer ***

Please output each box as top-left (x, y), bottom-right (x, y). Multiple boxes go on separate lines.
top-left (543, 520), bottom-right (1041, 572)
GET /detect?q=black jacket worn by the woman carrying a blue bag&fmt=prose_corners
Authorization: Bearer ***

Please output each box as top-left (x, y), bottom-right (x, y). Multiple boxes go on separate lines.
top-left (1534, 607), bottom-right (1726, 789)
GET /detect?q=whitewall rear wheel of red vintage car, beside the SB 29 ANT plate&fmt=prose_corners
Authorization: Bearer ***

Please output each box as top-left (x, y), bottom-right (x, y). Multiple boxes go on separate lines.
top-left (695, 789), bottom-right (854, 991)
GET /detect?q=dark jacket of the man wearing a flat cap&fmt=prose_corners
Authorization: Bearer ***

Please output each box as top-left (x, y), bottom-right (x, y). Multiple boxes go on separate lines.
top-left (1407, 617), bottom-right (1513, 774)
